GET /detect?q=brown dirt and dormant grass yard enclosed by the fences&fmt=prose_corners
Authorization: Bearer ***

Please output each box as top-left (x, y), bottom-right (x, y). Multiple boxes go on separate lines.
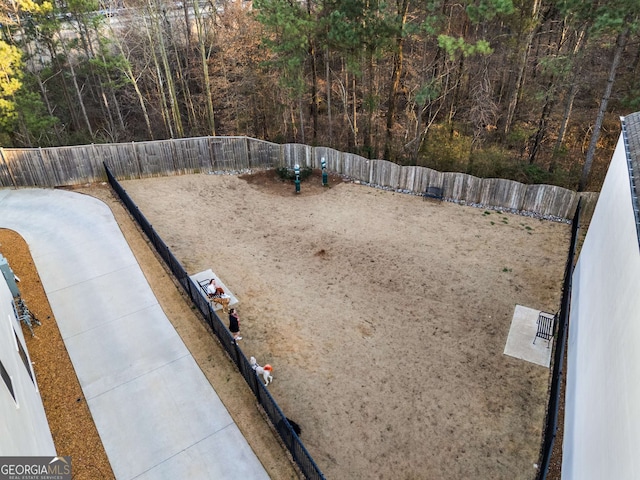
top-left (100, 172), bottom-right (570, 479)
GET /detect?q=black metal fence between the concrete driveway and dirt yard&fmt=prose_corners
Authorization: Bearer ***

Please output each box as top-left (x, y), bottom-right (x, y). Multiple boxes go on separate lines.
top-left (104, 164), bottom-right (324, 480)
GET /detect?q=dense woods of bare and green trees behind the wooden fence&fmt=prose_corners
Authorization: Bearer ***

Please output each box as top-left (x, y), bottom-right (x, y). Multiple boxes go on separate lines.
top-left (0, 0), bottom-right (640, 190)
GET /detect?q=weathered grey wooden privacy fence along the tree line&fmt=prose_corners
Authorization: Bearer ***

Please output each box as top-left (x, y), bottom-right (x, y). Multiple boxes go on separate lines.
top-left (0, 137), bottom-right (597, 219)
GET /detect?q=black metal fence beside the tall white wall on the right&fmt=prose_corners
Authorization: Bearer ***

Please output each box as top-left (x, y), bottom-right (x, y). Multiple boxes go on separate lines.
top-left (537, 197), bottom-right (582, 480)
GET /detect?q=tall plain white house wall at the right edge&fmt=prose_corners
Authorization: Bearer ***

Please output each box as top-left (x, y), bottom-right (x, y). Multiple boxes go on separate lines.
top-left (562, 136), bottom-right (640, 480)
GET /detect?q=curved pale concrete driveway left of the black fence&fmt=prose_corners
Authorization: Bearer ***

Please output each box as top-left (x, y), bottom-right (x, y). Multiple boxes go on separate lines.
top-left (0, 189), bottom-right (269, 480)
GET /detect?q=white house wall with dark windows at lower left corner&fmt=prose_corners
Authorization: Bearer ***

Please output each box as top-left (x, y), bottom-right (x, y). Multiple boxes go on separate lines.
top-left (0, 268), bottom-right (56, 456)
